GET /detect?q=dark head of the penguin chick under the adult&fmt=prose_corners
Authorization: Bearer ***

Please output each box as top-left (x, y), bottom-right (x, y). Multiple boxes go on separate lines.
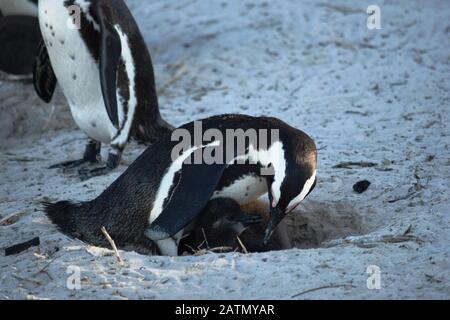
top-left (199, 198), bottom-right (262, 248)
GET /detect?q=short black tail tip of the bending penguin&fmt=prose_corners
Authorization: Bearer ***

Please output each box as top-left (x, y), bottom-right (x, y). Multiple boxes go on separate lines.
top-left (42, 201), bottom-right (83, 238)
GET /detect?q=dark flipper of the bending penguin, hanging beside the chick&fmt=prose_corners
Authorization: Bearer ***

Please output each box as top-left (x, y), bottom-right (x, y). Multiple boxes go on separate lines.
top-left (147, 164), bottom-right (227, 241)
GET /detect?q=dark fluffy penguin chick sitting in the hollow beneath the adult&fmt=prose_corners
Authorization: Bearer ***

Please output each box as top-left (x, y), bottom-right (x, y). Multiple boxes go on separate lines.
top-left (179, 198), bottom-right (262, 254)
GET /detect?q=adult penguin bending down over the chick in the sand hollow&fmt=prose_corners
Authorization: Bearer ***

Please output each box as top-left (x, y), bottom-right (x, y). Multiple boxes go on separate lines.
top-left (45, 115), bottom-right (317, 256)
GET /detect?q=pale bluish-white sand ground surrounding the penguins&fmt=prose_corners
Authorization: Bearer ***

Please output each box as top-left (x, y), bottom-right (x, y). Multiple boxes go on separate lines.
top-left (0, 0), bottom-right (450, 299)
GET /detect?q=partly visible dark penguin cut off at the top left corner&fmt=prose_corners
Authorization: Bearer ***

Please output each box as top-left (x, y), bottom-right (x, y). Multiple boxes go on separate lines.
top-left (0, 0), bottom-right (42, 76)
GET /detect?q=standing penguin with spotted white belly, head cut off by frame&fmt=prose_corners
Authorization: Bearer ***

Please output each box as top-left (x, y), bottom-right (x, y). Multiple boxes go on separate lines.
top-left (34, 0), bottom-right (173, 178)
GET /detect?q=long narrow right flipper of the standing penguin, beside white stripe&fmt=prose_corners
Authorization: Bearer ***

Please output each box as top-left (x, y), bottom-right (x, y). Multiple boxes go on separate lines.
top-left (96, 1), bottom-right (122, 128)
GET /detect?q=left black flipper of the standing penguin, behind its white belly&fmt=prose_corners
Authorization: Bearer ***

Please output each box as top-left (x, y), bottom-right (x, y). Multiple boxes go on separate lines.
top-left (33, 40), bottom-right (57, 103)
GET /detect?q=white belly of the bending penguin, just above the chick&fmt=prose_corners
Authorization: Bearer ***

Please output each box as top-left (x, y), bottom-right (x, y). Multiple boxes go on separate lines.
top-left (211, 175), bottom-right (267, 205)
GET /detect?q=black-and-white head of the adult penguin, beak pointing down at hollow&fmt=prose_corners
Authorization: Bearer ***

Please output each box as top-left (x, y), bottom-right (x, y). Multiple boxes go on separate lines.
top-left (264, 136), bottom-right (317, 243)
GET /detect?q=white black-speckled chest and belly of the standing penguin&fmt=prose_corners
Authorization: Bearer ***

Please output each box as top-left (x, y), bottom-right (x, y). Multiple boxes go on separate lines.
top-left (39, 0), bottom-right (117, 144)
